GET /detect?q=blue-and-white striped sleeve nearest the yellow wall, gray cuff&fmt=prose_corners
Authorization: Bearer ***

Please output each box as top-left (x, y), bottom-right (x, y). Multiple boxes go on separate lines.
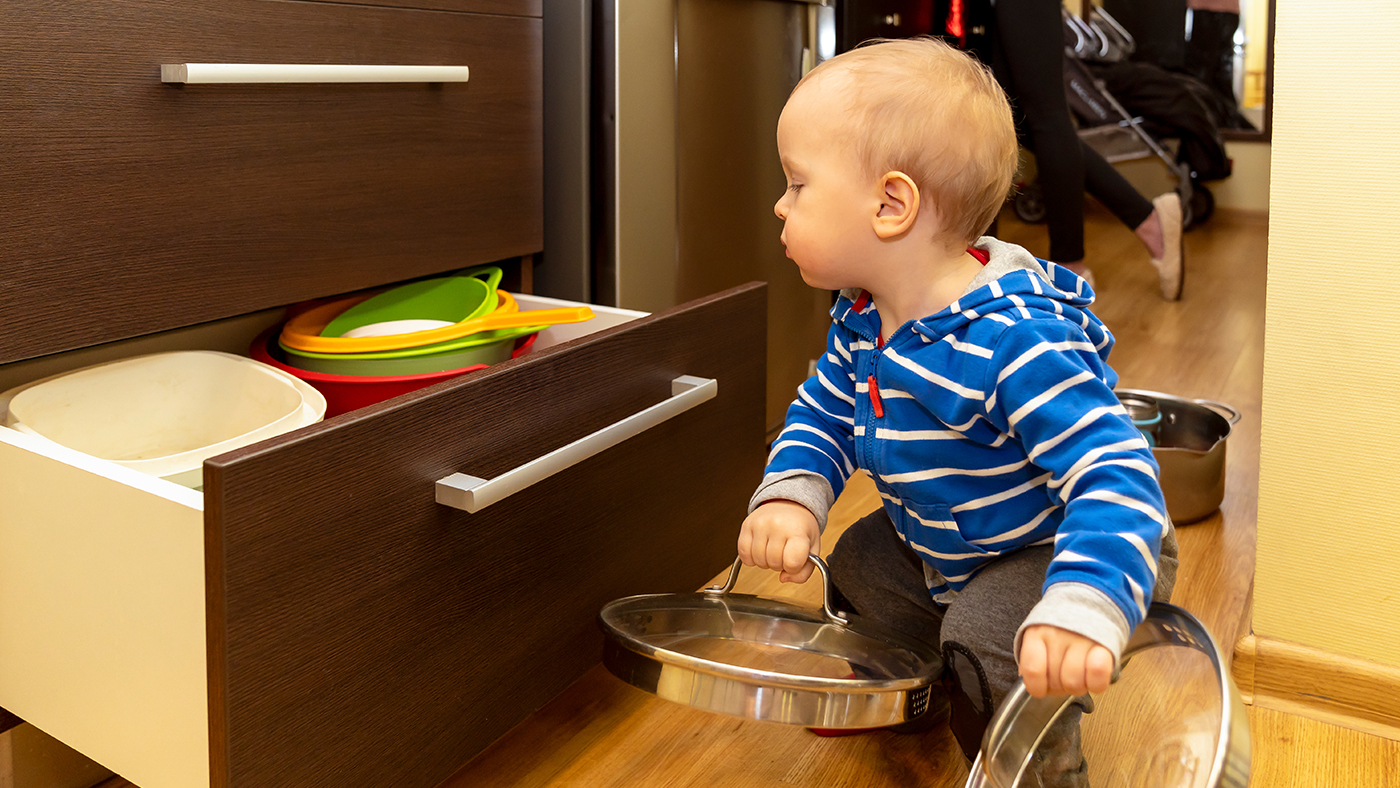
top-left (986, 319), bottom-right (1169, 643)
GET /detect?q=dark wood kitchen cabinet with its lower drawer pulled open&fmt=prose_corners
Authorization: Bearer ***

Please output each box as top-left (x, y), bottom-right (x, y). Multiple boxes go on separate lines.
top-left (0, 0), bottom-right (766, 788)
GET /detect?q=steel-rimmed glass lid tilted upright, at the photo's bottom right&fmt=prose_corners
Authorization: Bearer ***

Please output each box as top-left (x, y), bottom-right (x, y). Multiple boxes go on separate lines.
top-left (967, 603), bottom-right (1250, 788)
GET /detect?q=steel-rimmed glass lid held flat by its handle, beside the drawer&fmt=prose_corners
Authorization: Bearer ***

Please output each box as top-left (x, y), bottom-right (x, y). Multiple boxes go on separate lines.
top-left (598, 556), bottom-right (944, 728)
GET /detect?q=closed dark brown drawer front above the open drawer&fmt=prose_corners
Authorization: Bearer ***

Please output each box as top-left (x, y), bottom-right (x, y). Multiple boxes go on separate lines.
top-left (0, 0), bottom-right (543, 363)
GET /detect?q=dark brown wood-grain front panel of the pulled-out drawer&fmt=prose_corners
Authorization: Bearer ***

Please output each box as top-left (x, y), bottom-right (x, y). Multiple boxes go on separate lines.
top-left (204, 284), bottom-right (766, 788)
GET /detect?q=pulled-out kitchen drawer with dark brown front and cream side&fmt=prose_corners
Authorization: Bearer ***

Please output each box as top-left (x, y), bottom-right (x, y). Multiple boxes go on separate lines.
top-left (0, 284), bottom-right (766, 788)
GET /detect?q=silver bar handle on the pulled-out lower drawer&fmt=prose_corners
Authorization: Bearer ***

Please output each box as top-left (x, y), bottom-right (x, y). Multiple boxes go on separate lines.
top-left (437, 375), bottom-right (720, 512)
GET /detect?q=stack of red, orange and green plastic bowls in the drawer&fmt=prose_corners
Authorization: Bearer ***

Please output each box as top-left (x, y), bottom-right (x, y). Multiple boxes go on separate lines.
top-left (251, 266), bottom-right (592, 417)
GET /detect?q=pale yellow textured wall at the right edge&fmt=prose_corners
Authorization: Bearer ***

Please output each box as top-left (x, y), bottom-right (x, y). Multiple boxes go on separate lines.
top-left (1253, 0), bottom-right (1400, 666)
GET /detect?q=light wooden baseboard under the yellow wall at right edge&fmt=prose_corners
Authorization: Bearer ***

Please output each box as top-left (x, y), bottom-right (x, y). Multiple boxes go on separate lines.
top-left (1231, 634), bottom-right (1400, 740)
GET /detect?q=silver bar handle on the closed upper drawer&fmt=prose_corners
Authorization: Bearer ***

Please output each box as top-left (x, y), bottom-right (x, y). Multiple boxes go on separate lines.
top-left (161, 63), bottom-right (468, 85)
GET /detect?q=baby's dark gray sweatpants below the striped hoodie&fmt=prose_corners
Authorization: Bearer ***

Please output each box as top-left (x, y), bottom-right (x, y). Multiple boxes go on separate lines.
top-left (829, 509), bottom-right (1176, 788)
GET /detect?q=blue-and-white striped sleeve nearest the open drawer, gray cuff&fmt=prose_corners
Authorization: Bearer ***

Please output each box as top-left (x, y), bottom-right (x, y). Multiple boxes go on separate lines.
top-left (752, 325), bottom-right (855, 525)
